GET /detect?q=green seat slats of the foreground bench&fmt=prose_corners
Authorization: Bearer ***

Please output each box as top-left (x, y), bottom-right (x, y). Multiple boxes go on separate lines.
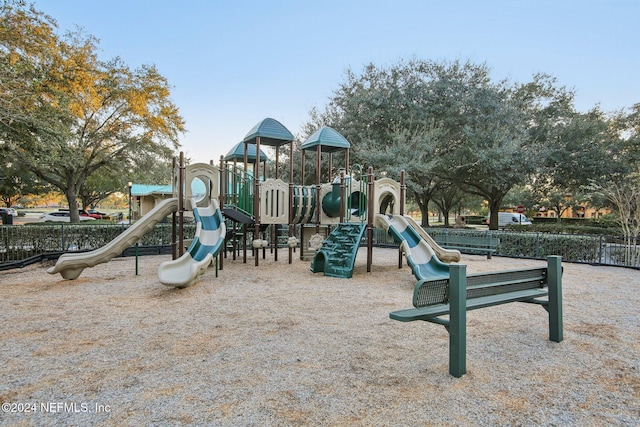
top-left (389, 288), bottom-right (549, 322)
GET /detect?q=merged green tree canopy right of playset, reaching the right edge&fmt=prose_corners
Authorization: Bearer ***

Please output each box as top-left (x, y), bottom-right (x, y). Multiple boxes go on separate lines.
top-left (305, 59), bottom-right (639, 229)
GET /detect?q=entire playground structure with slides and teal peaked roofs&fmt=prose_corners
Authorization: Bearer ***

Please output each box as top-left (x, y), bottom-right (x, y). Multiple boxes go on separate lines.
top-left (48, 118), bottom-right (460, 288)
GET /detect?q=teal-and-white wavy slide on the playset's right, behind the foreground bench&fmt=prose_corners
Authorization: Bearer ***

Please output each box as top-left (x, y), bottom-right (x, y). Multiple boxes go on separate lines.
top-left (375, 214), bottom-right (449, 280)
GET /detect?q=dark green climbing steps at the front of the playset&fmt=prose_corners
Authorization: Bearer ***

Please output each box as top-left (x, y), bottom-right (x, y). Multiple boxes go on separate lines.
top-left (311, 223), bottom-right (366, 279)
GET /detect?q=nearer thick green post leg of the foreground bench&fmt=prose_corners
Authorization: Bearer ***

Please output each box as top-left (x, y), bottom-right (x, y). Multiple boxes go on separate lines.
top-left (449, 264), bottom-right (467, 378)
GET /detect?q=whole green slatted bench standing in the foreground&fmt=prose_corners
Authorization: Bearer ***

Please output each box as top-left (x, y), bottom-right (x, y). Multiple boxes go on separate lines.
top-left (389, 256), bottom-right (563, 378)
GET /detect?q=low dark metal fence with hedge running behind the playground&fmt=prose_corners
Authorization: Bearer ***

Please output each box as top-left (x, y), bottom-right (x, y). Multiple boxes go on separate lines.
top-left (0, 223), bottom-right (640, 269)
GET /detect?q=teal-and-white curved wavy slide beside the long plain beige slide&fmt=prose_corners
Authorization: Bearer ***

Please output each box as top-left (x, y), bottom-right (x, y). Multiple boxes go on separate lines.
top-left (158, 199), bottom-right (226, 288)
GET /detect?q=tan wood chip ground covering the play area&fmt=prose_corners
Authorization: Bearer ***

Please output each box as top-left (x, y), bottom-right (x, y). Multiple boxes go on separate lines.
top-left (0, 248), bottom-right (640, 426)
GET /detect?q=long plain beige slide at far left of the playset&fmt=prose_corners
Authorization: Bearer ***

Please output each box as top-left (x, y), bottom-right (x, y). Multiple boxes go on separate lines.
top-left (47, 198), bottom-right (178, 280)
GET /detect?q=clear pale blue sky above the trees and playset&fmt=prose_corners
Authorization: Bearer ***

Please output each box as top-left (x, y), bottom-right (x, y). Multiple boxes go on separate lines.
top-left (35, 0), bottom-right (640, 162)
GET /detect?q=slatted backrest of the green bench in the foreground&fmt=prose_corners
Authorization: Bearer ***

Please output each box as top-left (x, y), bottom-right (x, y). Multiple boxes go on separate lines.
top-left (413, 267), bottom-right (548, 308)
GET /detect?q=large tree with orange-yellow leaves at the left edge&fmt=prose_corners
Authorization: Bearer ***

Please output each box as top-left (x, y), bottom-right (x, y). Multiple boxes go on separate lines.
top-left (0, 3), bottom-right (184, 221)
